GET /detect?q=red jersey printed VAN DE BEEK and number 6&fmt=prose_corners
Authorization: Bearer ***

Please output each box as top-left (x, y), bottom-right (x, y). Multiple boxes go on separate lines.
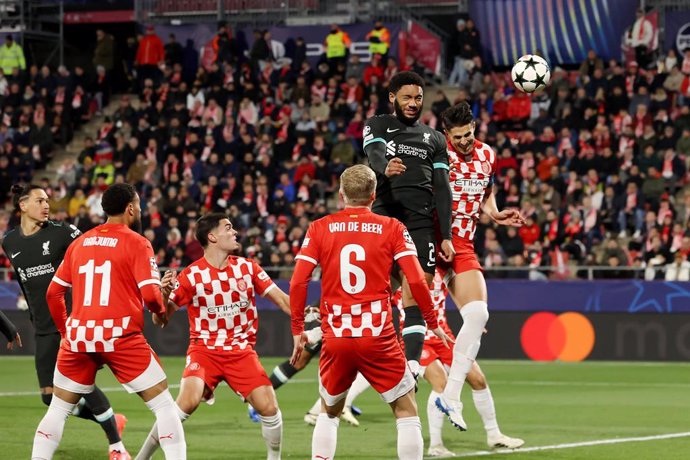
top-left (296, 208), bottom-right (417, 337)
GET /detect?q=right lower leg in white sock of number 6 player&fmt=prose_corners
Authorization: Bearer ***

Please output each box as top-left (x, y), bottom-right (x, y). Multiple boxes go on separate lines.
top-left (390, 389), bottom-right (424, 460)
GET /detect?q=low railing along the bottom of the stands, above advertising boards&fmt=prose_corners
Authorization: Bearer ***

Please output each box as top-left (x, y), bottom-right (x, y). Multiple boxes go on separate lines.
top-left (0, 265), bottom-right (683, 282)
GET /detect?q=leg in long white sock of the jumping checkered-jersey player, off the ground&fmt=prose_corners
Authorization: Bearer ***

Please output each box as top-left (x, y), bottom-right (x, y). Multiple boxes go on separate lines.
top-left (437, 270), bottom-right (489, 431)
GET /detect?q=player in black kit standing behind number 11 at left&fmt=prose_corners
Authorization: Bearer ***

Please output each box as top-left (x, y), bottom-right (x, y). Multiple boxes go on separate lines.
top-left (2, 185), bottom-right (127, 460)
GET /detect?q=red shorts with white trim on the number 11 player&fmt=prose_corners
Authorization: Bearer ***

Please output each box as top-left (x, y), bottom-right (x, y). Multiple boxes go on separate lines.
top-left (53, 334), bottom-right (165, 394)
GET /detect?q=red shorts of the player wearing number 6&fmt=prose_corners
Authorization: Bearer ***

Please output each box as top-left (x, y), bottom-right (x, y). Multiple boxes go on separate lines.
top-left (319, 335), bottom-right (415, 406)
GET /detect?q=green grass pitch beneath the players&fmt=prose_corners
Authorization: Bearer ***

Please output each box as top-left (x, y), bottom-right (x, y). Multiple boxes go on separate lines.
top-left (0, 357), bottom-right (690, 460)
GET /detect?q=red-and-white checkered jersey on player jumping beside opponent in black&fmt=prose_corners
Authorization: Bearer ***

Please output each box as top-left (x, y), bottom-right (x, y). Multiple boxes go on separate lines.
top-left (448, 141), bottom-right (496, 241)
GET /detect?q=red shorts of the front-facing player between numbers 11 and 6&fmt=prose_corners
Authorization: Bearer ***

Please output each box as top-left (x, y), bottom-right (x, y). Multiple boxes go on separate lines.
top-left (182, 347), bottom-right (271, 399)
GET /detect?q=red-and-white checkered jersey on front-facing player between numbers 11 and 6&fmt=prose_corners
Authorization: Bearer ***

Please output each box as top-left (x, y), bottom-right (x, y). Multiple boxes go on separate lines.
top-left (170, 256), bottom-right (276, 351)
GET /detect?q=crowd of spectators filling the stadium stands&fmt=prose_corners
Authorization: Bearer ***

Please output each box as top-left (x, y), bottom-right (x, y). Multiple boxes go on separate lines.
top-left (0, 21), bottom-right (690, 279)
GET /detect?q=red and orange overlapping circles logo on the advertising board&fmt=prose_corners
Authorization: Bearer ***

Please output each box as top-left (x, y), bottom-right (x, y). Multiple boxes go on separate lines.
top-left (520, 312), bottom-right (595, 362)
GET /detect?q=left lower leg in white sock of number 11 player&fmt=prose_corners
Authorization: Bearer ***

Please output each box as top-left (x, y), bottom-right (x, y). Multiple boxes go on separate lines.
top-left (31, 388), bottom-right (81, 460)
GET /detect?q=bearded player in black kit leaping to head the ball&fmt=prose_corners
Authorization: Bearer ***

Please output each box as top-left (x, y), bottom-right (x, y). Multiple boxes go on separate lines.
top-left (363, 72), bottom-right (455, 375)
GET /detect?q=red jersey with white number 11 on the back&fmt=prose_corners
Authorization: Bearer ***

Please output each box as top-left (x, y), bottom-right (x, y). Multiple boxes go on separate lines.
top-left (53, 224), bottom-right (160, 352)
